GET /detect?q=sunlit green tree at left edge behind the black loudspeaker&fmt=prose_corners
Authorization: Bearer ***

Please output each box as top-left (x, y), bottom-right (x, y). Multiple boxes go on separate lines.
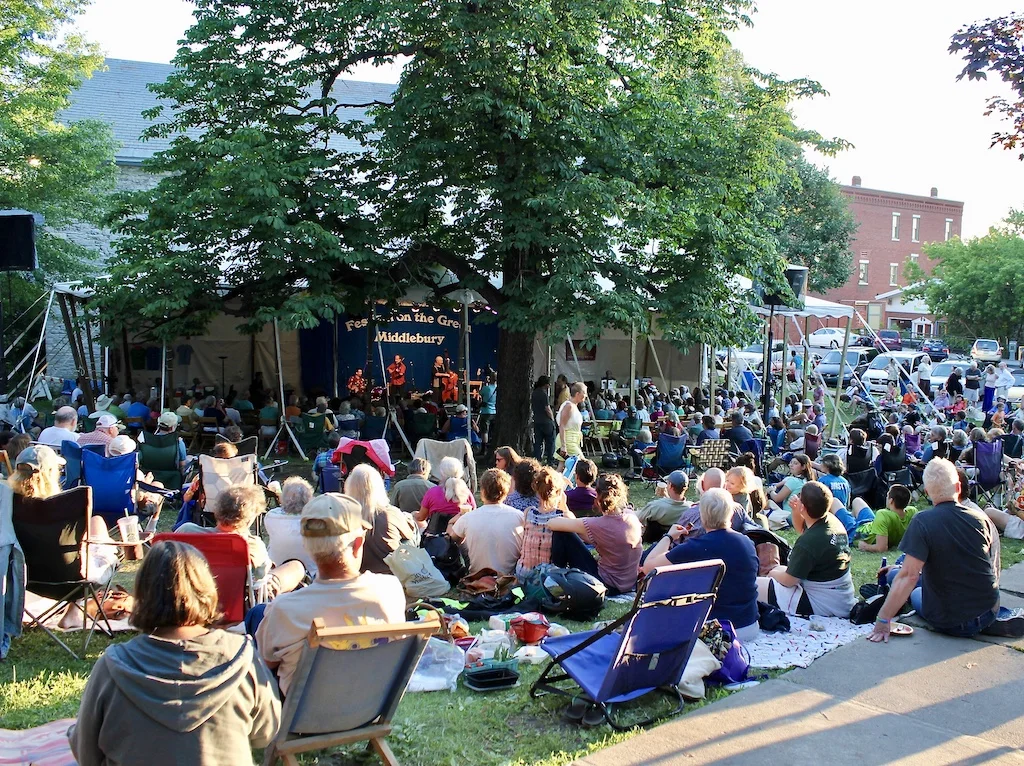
top-left (0, 0), bottom-right (116, 383)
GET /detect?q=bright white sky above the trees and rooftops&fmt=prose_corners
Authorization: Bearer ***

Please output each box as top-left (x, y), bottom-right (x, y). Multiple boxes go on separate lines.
top-left (79, 0), bottom-right (1024, 237)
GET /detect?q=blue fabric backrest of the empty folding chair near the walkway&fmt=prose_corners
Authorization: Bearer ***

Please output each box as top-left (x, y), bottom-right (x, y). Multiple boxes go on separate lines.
top-left (595, 559), bottom-right (725, 703)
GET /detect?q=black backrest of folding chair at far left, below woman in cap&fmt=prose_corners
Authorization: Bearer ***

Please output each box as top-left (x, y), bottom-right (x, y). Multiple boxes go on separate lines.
top-left (13, 486), bottom-right (92, 599)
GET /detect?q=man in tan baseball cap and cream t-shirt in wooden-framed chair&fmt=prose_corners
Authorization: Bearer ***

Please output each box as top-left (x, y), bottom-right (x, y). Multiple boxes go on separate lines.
top-left (246, 493), bottom-right (406, 694)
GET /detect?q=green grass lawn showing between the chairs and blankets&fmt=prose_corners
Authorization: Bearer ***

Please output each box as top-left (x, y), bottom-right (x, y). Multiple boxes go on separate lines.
top-left (0, 464), bottom-right (1024, 766)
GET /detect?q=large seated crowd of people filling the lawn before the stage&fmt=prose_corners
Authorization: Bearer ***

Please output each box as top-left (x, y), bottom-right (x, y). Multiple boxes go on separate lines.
top-left (6, 360), bottom-right (1024, 763)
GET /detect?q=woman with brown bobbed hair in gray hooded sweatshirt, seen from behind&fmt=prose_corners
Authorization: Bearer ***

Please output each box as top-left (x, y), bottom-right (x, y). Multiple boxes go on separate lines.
top-left (68, 541), bottom-right (281, 766)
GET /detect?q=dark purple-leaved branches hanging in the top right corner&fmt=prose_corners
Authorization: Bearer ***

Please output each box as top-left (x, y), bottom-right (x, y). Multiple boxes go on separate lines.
top-left (949, 13), bottom-right (1024, 160)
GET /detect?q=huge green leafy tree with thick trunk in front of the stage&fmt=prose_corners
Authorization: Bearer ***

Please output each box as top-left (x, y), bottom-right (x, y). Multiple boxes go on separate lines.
top-left (96, 0), bottom-right (843, 452)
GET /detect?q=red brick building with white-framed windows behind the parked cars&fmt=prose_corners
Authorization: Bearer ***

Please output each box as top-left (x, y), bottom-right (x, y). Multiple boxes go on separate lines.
top-left (818, 175), bottom-right (964, 335)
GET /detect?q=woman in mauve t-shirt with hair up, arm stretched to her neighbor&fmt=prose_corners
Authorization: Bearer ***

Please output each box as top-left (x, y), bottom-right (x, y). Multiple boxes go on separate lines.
top-left (548, 473), bottom-right (643, 596)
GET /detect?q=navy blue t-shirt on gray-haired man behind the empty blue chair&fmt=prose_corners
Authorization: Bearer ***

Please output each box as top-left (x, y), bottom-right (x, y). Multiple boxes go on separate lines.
top-left (667, 529), bottom-right (758, 629)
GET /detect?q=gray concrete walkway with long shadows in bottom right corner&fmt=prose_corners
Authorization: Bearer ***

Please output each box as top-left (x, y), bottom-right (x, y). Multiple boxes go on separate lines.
top-left (578, 564), bottom-right (1024, 766)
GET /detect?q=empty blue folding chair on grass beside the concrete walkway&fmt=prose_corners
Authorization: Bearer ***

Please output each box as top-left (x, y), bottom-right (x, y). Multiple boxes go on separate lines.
top-left (529, 559), bottom-right (725, 731)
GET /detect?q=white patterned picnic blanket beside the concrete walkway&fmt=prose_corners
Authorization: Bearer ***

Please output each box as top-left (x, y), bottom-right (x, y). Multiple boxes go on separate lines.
top-left (744, 616), bottom-right (874, 670)
